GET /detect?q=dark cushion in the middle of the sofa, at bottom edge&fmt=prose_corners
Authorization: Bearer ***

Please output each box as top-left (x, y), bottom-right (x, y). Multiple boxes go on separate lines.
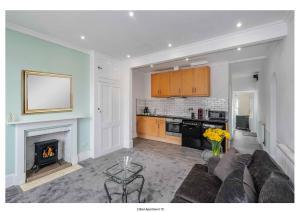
top-left (215, 166), bottom-right (257, 203)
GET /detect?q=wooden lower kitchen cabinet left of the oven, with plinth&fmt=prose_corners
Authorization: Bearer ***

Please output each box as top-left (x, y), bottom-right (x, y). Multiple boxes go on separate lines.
top-left (136, 116), bottom-right (181, 145)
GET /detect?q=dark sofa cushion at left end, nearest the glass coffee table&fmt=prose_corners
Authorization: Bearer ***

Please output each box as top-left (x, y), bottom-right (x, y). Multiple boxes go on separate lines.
top-left (172, 164), bottom-right (222, 203)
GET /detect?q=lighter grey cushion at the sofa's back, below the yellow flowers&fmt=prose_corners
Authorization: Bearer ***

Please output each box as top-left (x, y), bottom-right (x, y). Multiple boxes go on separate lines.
top-left (214, 148), bottom-right (252, 181)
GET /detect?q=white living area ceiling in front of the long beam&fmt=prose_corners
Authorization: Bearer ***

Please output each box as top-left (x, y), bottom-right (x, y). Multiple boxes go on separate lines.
top-left (6, 11), bottom-right (288, 59)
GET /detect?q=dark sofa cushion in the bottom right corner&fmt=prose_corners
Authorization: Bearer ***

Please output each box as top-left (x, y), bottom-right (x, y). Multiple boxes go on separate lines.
top-left (258, 172), bottom-right (294, 203)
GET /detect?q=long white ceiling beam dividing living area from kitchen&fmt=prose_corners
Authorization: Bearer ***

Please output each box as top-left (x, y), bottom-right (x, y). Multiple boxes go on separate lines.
top-left (130, 21), bottom-right (288, 68)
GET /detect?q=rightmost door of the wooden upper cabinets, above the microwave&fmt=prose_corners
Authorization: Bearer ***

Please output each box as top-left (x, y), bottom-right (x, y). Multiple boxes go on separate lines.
top-left (193, 66), bottom-right (210, 96)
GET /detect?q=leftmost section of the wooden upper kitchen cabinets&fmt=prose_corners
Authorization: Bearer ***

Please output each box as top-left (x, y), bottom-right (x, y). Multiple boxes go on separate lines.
top-left (151, 72), bottom-right (170, 97)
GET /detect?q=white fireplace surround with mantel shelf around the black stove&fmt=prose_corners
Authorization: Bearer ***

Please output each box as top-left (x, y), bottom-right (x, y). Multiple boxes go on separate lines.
top-left (14, 118), bottom-right (78, 185)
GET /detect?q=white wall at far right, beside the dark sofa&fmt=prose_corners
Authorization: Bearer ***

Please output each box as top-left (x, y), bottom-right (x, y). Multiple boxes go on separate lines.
top-left (258, 14), bottom-right (294, 180)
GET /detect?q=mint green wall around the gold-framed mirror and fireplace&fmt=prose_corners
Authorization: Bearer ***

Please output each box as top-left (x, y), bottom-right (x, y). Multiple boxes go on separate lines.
top-left (5, 29), bottom-right (90, 174)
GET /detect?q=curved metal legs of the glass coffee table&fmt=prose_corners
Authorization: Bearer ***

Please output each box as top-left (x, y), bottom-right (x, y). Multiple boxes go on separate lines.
top-left (104, 175), bottom-right (145, 203)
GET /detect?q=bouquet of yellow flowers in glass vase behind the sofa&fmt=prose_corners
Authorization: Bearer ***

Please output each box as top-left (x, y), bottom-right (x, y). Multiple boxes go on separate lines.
top-left (203, 128), bottom-right (230, 156)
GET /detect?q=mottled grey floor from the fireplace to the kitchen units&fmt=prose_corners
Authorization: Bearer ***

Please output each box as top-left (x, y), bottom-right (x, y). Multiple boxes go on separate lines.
top-left (6, 139), bottom-right (205, 203)
